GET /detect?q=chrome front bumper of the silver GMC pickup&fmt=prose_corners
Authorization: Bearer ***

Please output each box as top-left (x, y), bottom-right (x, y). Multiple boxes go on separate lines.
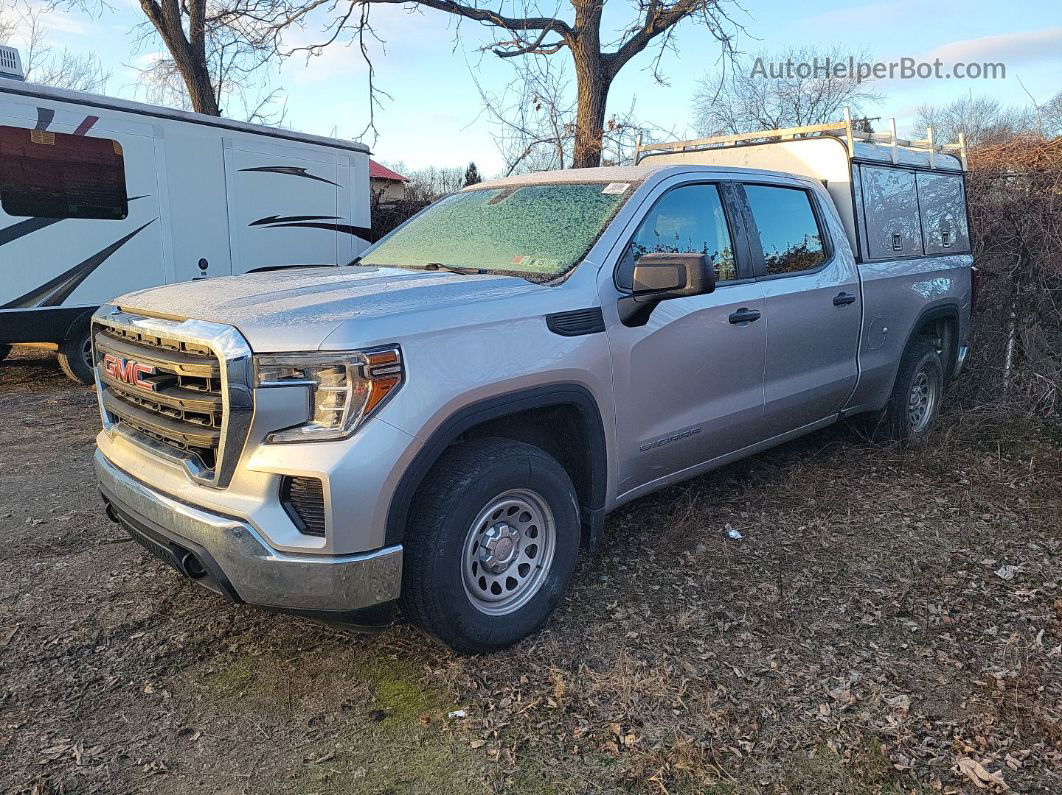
top-left (95, 450), bottom-right (402, 624)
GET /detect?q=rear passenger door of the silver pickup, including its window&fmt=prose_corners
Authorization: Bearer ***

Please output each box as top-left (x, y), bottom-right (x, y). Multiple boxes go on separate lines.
top-left (742, 183), bottom-right (861, 435)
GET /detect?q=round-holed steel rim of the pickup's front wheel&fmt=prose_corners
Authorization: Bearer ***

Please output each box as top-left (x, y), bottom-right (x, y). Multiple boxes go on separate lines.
top-left (461, 488), bottom-right (556, 616)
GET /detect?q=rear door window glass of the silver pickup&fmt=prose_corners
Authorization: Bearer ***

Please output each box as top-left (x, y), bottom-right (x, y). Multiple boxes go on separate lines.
top-left (744, 185), bottom-right (826, 276)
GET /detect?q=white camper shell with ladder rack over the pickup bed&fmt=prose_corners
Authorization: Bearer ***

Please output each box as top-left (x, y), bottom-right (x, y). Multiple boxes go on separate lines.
top-left (635, 113), bottom-right (970, 262)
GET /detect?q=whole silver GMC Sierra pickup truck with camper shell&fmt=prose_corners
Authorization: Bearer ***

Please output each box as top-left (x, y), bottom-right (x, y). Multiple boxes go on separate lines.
top-left (93, 122), bottom-right (974, 653)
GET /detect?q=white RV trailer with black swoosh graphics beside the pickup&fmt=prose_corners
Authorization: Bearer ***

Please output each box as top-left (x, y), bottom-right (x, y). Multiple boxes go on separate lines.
top-left (0, 48), bottom-right (370, 381)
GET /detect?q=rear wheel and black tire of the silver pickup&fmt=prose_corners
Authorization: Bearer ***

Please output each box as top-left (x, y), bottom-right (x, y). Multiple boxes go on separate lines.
top-left (881, 338), bottom-right (944, 447)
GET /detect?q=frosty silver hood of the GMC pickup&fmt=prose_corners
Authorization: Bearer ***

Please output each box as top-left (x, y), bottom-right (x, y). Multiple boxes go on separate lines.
top-left (118, 266), bottom-right (549, 351)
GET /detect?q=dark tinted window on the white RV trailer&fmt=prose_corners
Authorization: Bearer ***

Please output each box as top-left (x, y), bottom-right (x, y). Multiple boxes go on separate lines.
top-left (0, 126), bottom-right (129, 220)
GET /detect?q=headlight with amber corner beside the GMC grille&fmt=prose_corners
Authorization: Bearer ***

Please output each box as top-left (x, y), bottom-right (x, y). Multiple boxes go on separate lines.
top-left (255, 345), bottom-right (402, 442)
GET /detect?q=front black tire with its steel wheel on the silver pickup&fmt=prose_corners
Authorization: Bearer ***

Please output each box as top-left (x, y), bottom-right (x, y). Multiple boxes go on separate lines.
top-left (400, 438), bottom-right (580, 654)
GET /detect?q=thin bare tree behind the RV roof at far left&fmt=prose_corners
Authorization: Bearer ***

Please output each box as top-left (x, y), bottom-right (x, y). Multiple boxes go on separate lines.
top-left (0, 3), bottom-right (110, 92)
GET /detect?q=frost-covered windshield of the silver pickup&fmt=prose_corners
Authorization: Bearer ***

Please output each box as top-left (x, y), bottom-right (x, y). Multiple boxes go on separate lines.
top-left (360, 183), bottom-right (633, 281)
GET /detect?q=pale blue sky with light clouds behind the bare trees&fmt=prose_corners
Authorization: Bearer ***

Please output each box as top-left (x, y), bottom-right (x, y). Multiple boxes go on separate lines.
top-left (0, 0), bottom-right (1062, 174)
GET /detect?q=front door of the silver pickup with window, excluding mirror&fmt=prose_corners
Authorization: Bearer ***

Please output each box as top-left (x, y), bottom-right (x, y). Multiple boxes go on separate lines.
top-left (609, 183), bottom-right (767, 496)
